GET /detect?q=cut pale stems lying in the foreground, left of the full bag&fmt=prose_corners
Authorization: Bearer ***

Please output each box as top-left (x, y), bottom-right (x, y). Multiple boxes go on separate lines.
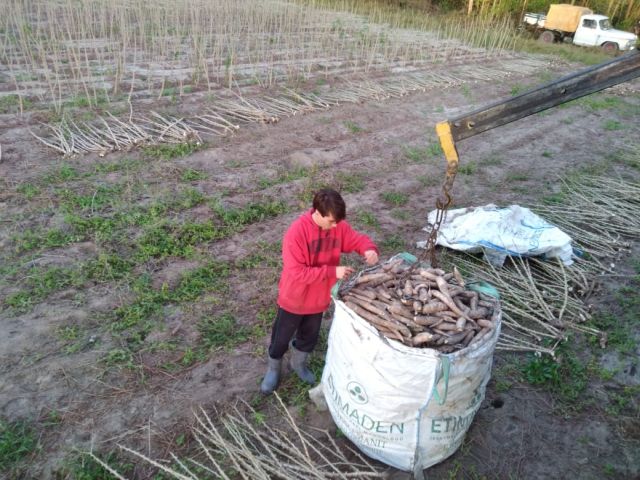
top-left (99, 393), bottom-right (384, 480)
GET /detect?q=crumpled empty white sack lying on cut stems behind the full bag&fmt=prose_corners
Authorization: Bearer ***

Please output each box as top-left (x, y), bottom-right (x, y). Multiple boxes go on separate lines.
top-left (419, 204), bottom-right (573, 266)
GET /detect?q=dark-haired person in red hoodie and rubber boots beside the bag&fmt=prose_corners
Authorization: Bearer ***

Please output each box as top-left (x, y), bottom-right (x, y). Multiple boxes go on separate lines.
top-left (260, 189), bottom-right (378, 394)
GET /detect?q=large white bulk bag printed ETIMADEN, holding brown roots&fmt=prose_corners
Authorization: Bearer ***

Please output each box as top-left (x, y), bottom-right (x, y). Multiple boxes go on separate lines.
top-left (322, 298), bottom-right (500, 473)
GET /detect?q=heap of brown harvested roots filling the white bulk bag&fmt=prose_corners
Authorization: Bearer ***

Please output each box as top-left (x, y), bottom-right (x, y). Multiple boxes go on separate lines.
top-left (340, 259), bottom-right (499, 353)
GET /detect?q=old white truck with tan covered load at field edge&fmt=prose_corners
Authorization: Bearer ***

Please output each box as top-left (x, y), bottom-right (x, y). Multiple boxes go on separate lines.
top-left (522, 4), bottom-right (638, 54)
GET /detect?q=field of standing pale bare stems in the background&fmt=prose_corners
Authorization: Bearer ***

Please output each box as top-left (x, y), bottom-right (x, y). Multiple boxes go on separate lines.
top-left (0, 0), bottom-right (512, 108)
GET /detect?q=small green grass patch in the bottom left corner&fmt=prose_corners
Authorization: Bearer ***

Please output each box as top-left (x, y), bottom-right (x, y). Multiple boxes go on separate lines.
top-left (0, 417), bottom-right (38, 470)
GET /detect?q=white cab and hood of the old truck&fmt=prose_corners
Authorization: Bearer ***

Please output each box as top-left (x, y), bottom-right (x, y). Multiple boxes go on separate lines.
top-left (573, 14), bottom-right (638, 52)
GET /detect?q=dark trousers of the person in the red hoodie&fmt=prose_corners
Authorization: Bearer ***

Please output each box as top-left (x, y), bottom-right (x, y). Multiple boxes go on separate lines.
top-left (269, 307), bottom-right (323, 359)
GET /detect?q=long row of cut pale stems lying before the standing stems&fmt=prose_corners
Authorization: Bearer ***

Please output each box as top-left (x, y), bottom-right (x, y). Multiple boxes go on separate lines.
top-left (33, 59), bottom-right (544, 156)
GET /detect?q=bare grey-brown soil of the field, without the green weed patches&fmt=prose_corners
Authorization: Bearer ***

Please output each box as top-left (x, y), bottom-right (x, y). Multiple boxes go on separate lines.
top-left (0, 53), bottom-right (640, 479)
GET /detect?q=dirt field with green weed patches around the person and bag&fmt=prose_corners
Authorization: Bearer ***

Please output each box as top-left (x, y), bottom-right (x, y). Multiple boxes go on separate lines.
top-left (0, 37), bottom-right (640, 479)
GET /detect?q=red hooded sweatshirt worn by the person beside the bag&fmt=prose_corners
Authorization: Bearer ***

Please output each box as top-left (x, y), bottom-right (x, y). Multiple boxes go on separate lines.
top-left (278, 208), bottom-right (378, 315)
